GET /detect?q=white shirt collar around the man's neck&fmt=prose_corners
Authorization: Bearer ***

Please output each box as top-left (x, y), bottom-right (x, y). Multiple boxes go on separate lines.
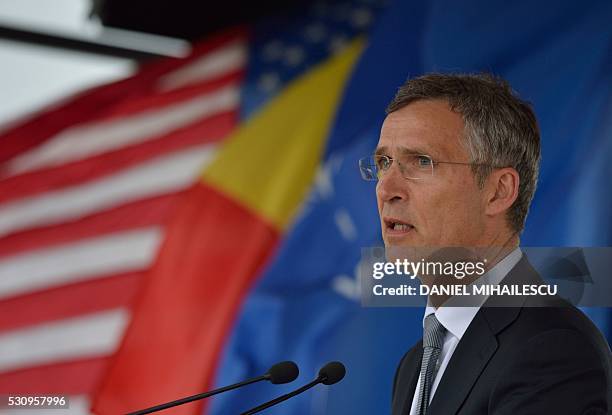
top-left (423, 247), bottom-right (523, 340)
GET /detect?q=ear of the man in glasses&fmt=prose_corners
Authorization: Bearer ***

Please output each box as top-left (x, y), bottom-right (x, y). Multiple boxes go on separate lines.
top-left (485, 167), bottom-right (520, 216)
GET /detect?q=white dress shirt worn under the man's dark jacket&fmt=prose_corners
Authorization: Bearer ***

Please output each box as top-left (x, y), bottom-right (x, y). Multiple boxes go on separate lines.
top-left (410, 247), bottom-right (523, 415)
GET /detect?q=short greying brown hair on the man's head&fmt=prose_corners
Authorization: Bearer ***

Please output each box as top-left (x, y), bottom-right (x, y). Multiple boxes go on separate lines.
top-left (387, 73), bottom-right (540, 232)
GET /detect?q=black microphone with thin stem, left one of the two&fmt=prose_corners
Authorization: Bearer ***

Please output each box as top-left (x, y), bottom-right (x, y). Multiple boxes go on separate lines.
top-left (127, 361), bottom-right (300, 415)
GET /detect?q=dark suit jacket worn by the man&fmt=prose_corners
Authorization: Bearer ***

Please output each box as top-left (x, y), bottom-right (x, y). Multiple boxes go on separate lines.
top-left (392, 257), bottom-right (612, 415)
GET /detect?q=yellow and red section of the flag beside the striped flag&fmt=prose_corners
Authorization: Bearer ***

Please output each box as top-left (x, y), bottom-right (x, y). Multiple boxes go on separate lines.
top-left (94, 40), bottom-right (363, 414)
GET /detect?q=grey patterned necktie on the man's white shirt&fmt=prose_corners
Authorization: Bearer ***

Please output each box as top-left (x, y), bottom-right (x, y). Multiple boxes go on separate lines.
top-left (416, 314), bottom-right (446, 415)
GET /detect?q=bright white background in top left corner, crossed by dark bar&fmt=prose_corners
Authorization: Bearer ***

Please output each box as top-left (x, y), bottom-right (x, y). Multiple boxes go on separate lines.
top-left (0, 0), bottom-right (134, 130)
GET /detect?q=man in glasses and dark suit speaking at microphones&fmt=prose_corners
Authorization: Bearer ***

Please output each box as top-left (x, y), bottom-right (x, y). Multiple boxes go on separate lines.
top-left (360, 74), bottom-right (612, 415)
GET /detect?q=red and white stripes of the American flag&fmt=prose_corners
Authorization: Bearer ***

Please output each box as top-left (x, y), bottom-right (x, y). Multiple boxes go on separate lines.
top-left (0, 30), bottom-right (246, 414)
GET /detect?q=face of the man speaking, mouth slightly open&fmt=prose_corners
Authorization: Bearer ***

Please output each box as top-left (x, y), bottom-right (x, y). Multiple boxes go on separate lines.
top-left (376, 100), bottom-right (485, 247)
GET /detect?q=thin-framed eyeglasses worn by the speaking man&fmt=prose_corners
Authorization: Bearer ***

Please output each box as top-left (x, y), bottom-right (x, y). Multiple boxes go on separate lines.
top-left (359, 154), bottom-right (486, 181)
